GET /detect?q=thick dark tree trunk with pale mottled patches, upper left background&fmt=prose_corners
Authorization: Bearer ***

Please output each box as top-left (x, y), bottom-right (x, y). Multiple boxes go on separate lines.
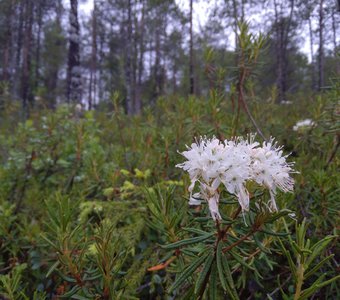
top-left (66, 0), bottom-right (82, 103)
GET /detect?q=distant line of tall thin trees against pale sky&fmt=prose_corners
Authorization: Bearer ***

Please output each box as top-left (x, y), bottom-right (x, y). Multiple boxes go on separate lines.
top-left (0, 0), bottom-right (340, 114)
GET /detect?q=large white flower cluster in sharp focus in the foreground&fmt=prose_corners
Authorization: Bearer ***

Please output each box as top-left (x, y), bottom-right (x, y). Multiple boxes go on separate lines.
top-left (176, 135), bottom-right (294, 220)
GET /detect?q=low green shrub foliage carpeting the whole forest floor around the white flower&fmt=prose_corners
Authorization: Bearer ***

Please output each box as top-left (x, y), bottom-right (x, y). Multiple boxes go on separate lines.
top-left (0, 78), bottom-right (340, 299)
